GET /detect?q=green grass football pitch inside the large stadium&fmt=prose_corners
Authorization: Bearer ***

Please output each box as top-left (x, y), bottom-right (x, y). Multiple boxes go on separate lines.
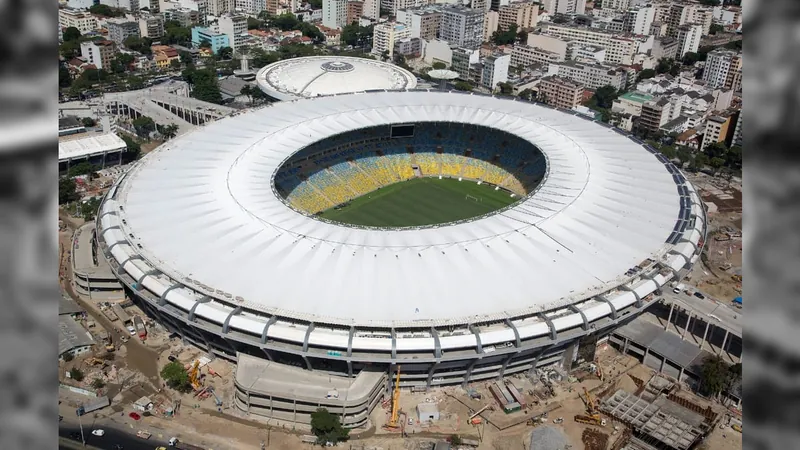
top-left (320, 178), bottom-right (519, 227)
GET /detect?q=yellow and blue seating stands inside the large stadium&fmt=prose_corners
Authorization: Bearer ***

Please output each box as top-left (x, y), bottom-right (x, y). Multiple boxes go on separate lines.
top-left (275, 123), bottom-right (547, 213)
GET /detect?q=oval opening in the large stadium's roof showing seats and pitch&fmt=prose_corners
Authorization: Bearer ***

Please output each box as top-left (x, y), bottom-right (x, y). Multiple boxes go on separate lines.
top-left (273, 122), bottom-right (547, 229)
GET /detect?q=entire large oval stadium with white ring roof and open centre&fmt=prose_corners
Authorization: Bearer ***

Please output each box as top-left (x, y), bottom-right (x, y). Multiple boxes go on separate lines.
top-left (97, 91), bottom-right (706, 426)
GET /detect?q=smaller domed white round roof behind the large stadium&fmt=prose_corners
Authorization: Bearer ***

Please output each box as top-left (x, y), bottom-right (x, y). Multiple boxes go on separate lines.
top-left (256, 56), bottom-right (417, 100)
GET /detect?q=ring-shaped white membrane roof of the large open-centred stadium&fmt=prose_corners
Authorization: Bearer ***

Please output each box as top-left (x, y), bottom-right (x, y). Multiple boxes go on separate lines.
top-left (100, 91), bottom-right (692, 326)
